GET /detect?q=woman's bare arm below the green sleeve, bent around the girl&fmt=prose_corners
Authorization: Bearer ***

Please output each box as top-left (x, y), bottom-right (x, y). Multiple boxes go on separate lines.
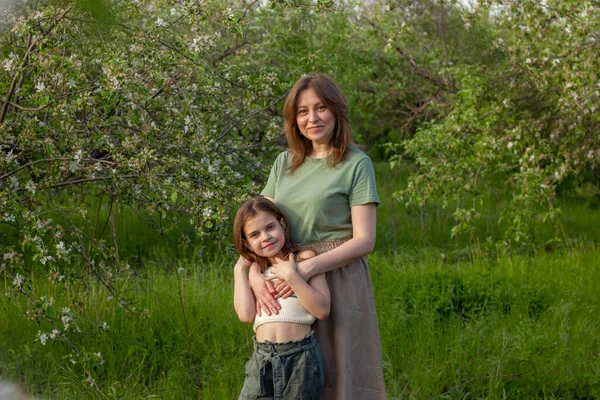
top-left (294, 203), bottom-right (377, 282)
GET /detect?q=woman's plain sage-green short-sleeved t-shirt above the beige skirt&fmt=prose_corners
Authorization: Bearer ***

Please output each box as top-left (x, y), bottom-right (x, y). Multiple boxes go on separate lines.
top-left (261, 146), bottom-right (379, 243)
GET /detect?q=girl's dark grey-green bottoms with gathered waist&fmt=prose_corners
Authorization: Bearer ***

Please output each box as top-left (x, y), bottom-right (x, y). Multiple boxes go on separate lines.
top-left (238, 332), bottom-right (325, 400)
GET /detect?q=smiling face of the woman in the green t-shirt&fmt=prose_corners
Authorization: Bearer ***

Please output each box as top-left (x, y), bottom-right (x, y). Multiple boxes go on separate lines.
top-left (296, 88), bottom-right (335, 145)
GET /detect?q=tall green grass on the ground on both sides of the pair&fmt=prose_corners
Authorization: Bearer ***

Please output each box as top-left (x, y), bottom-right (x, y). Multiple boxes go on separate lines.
top-left (0, 249), bottom-right (600, 399)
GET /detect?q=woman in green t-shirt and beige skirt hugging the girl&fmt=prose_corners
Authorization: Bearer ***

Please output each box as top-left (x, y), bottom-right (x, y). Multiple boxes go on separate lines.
top-left (250, 73), bottom-right (387, 400)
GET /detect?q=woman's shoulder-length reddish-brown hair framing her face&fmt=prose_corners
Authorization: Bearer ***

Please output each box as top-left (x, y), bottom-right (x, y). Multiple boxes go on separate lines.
top-left (283, 72), bottom-right (353, 172)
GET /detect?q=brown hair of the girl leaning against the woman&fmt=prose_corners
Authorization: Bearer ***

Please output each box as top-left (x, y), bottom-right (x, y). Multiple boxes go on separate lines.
top-left (233, 196), bottom-right (296, 271)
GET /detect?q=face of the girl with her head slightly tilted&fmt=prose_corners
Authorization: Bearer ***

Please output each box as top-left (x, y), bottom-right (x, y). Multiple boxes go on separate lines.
top-left (244, 211), bottom-right (286, 258)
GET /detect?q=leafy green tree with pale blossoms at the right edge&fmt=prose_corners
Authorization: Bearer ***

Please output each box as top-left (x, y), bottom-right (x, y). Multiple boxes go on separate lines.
top-left (392, 0), bottom-right (600, 244)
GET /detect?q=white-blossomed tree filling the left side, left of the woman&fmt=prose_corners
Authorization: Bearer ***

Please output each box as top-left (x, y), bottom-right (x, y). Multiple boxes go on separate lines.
top-left (0, 0), bottom-right (398, 390)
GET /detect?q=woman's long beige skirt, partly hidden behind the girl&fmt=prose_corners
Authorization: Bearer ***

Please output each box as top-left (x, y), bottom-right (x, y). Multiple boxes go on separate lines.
top-left (299, 240), bottom-right (387, 400)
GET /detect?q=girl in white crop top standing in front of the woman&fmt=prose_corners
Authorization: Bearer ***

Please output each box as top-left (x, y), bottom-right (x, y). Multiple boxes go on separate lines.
top-left (233, 197), bottom-right (330, 400)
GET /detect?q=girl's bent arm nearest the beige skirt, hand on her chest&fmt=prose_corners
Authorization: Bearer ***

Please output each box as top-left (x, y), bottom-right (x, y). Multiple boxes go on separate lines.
top-left (267, 254), bottom-right (331, 319)
